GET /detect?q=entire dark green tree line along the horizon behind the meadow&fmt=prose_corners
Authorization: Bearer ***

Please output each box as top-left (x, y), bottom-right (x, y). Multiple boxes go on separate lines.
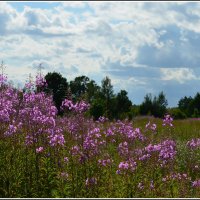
top-left (37, 72), bottom-right (200, 119)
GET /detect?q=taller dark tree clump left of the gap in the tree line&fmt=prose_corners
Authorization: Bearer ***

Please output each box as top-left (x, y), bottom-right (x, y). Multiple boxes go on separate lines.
top-left (40, 72), bottom-right (132, 119)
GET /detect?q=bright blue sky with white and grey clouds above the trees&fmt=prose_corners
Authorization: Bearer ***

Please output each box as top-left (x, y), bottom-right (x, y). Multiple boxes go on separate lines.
top-left (0, 1), bottom-right (200, 107)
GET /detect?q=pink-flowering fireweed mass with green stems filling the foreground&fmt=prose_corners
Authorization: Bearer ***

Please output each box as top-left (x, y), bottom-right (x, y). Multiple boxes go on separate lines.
top-left (0, 74), bottom-right (200, 198)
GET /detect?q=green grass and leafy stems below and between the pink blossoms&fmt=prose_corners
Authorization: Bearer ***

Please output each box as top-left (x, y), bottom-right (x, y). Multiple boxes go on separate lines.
top-left (0, 118), bottom-right (200, 198)
